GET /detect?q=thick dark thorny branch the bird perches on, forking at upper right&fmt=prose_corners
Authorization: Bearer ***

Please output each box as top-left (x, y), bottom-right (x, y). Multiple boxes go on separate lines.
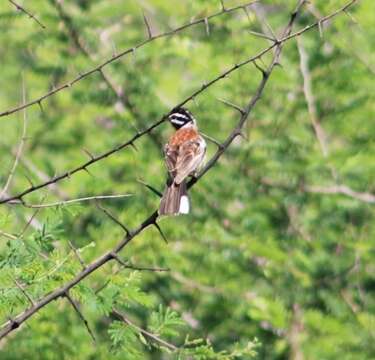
top-left (0, 0), bottom-right (362, 339)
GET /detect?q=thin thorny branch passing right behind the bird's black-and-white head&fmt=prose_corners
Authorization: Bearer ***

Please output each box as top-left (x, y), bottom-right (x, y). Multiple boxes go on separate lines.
top-left (0, 0), bottom-right (357, 204)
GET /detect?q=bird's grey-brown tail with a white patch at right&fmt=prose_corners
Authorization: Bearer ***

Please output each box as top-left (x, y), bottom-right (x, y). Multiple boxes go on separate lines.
top-left (159, 180), bottom-right (190, 215)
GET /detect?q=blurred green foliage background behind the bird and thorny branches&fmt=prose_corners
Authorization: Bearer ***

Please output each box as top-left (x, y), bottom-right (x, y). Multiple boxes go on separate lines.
top-left (0, 0), bottom-right (375, 360)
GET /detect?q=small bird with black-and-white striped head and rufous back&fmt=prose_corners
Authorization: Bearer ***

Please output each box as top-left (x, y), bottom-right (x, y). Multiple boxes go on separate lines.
top-left (159, 107), bottom-right (206, 215)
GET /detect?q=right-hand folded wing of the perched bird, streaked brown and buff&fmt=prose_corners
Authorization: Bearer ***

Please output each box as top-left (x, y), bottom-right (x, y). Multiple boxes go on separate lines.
top-left (174, 137), bottom-right (206, 184)
